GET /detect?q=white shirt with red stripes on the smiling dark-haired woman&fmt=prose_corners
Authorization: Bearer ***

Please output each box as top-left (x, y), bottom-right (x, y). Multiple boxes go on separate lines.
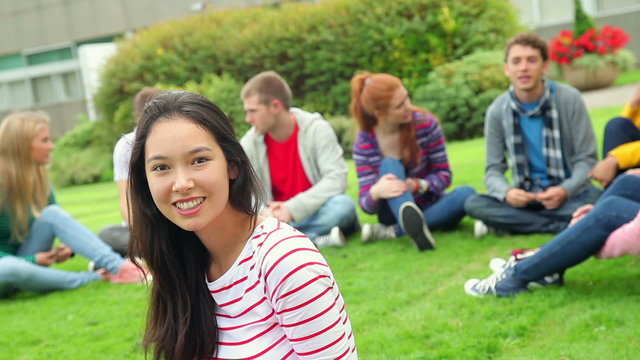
top-left (208, 217), bottom-right (358, 359)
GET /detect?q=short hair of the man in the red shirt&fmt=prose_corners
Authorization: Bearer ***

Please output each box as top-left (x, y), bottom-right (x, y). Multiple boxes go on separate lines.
top-left (240, 71), bottom-right (291, 110)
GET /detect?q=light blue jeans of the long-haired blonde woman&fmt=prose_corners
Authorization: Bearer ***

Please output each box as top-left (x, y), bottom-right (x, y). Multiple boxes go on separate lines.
top-left (0, 205), bottom-right (124, 297)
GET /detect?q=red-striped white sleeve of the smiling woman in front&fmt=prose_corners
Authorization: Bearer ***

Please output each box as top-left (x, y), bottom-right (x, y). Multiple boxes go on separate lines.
top-left (260, 228), bottom-right (356, 359)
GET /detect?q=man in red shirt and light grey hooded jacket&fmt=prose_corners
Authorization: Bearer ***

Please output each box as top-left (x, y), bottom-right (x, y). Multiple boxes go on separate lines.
top-left (240, 71), bottom-right (359, 248)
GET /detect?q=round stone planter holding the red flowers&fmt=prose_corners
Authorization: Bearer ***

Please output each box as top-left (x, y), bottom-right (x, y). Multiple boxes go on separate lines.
top-left (562, 63), bottom-right (620, 91)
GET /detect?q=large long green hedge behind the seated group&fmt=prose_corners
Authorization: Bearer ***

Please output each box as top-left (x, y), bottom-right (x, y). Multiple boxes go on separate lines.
top-left (96, 0), bottom-right (518, 131)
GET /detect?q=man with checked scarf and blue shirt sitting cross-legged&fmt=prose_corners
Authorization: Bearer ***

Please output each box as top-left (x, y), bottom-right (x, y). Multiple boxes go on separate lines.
top-left (465, 33), bottom-right (600, 237)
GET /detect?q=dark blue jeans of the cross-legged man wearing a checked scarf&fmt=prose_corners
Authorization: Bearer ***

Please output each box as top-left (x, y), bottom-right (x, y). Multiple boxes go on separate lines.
top-left (464, 185), bottom-right (602, 234)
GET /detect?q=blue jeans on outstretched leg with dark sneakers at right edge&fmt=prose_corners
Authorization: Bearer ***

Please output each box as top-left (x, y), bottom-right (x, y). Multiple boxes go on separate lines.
top-left (514, 175), bottom-right (640, 282)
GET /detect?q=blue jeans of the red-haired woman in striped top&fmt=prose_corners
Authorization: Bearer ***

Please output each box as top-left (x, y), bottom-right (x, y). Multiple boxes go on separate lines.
top-left (378, 158), bottom-right (476, 232)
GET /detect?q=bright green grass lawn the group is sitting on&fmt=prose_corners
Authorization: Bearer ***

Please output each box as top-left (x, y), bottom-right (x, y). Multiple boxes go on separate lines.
top-left (0, 107), bottom-right (640, 360)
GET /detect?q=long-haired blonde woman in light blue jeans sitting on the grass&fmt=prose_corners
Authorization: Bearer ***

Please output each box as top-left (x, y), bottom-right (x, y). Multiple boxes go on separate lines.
top-left (0, 112), bottom-right (144, 297)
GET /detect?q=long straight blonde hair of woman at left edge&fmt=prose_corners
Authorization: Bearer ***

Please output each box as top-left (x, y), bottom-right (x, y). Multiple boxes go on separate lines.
top-left (0, 111), bottom-right (50, 241)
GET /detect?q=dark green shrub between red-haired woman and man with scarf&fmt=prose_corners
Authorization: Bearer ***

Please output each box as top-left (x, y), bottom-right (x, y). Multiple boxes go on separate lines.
top-left (412, 51), bottom-right (509, 140)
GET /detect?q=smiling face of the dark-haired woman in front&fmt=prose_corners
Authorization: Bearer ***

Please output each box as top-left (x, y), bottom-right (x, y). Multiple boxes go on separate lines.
top-left (144, 118), bottom-right (237, 233)
